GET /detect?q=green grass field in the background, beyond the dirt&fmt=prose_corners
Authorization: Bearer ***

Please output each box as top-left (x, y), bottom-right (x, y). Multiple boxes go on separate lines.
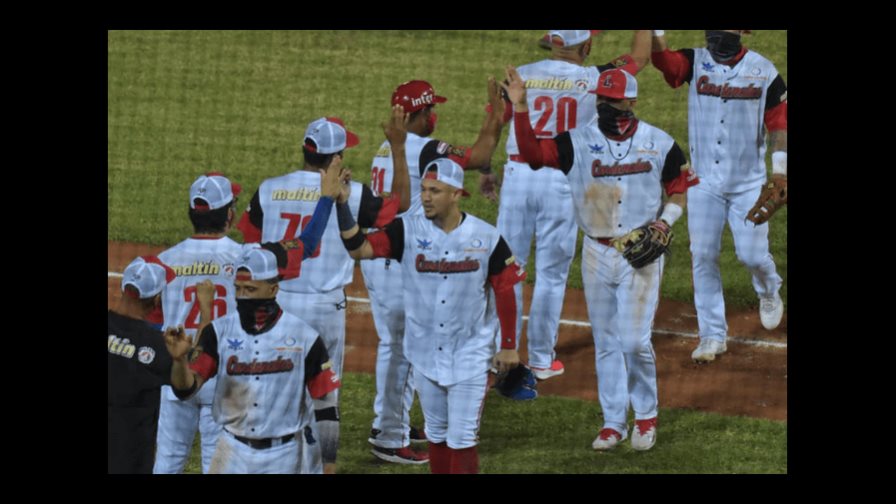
top-left (108, 30), bottom-right (787, 307)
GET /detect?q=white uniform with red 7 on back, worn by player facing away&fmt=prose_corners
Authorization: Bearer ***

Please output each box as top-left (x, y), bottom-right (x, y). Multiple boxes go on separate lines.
top-left (246, 170), bottom-right (398, 469)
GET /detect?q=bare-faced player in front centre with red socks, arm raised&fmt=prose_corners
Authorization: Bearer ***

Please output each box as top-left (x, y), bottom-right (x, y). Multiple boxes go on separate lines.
top-left (344, 158), bottom-right (525, 474)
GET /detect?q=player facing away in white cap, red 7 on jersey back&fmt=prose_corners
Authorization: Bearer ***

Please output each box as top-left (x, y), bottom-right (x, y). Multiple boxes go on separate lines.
top-left (239, 113), bottom-right (416, 473)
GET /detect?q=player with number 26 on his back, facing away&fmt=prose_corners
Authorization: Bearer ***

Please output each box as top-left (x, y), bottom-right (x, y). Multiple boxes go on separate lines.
top-left (153, 173), bottom-right (243, 474)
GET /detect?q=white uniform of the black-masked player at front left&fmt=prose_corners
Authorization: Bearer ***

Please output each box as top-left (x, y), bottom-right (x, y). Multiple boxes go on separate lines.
top-left (190, 309), bottom-right (340, 474)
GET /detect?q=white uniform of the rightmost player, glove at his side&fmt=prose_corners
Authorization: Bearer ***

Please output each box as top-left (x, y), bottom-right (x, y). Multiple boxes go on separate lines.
top-left (658, 48), bottom-right (787, 342)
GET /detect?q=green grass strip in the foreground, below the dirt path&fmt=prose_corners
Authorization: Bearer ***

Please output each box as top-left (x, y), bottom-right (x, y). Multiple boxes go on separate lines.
top-left (185, 373), bottom-right (787, 474)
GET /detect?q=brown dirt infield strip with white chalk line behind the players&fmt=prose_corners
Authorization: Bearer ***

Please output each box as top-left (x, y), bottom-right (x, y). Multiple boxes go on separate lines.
top-left (108, 242), bottom-right (787, 420)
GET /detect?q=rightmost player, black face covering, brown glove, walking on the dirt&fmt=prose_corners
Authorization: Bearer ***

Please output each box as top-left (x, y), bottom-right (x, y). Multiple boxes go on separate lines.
top-left (652, 30), bottom-right (787, 362)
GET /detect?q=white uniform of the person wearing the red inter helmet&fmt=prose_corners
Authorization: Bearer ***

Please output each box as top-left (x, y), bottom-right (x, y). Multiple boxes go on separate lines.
top-left (361, 132), bottom-right (480, 448)
